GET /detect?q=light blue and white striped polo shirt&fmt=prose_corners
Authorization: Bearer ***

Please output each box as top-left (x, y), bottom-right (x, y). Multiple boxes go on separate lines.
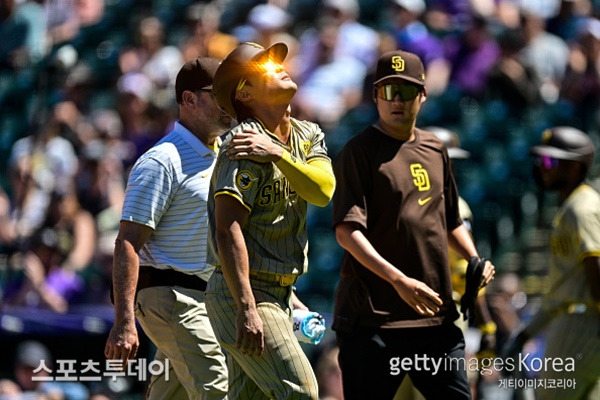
top-left (121, 123), bottom-right (217, 280)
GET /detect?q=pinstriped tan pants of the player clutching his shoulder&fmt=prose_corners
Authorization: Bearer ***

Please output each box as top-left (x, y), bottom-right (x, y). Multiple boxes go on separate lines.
top-left (206, 270), bottom-right (318, 400)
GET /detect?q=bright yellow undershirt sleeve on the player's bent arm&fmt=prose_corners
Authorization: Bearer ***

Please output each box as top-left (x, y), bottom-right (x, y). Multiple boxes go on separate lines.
top-left (275, 151), bottom-right (335, 207)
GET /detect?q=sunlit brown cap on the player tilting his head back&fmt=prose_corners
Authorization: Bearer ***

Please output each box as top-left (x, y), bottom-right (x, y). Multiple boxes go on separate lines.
top-left (213, 42), bottom-right (288, 118)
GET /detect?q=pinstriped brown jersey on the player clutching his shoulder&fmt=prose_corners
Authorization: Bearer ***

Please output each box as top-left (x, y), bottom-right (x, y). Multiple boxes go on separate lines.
top-left (208, 118), bottom-right (329, 275)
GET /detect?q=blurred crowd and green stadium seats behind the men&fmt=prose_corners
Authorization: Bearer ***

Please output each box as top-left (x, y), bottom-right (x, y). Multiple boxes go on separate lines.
top-left (0, 0), bottom-right (600, 398)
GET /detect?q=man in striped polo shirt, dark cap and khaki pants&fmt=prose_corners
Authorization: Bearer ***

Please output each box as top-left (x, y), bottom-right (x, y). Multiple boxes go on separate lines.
top-left (105, 58), bottom-right (231, 400)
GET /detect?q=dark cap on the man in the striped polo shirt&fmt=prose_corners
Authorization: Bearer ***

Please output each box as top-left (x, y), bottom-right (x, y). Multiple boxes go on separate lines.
top-left (175, 57), bottom-right (220, 103)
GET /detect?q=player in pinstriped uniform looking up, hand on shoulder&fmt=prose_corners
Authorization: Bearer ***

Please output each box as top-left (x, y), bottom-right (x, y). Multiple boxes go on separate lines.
top-left (206, 43), bottom-right (335, 399)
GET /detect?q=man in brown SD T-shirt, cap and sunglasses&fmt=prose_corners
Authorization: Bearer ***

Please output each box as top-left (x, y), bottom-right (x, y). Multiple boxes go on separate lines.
top-left (333, 51), bottom-right (494, 399)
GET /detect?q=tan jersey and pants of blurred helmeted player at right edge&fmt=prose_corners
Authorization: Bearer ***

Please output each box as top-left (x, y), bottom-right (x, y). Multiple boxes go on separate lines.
top-left (536, 184), bottom-right (600, 400)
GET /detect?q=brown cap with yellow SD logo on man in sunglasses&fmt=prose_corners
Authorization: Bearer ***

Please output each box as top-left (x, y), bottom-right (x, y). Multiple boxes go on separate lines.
top-left (374, 50), bottom-right (425, 86)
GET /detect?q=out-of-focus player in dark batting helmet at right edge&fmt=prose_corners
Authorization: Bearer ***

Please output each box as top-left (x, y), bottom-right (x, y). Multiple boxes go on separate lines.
top-left (505, 126), bottom-right (600, 400)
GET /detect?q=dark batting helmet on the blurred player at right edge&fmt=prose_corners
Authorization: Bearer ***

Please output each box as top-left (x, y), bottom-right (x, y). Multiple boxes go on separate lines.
top-left (531, 126), bottom-right (594, 168)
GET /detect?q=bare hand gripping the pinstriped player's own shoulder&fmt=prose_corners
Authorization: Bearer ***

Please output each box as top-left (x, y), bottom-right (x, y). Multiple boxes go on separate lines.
top-left (227, 128), bottom-right (283, 163)
